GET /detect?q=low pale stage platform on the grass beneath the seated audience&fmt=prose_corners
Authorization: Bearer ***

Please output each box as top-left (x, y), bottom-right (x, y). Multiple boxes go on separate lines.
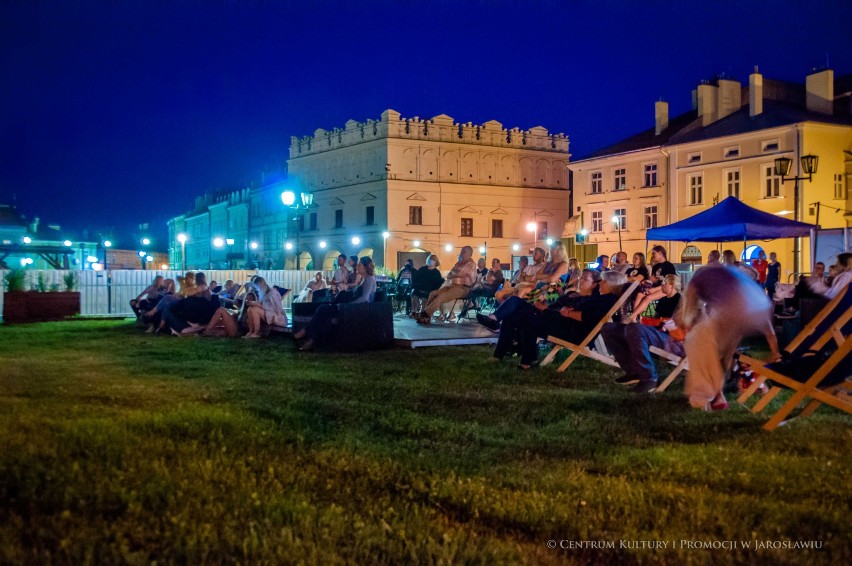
top-left (393, 314), bottom-right (497, 348)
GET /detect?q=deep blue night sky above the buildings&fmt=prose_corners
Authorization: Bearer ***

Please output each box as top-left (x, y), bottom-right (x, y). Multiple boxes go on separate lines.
top-left (0, 0), bottom-right (852, 247)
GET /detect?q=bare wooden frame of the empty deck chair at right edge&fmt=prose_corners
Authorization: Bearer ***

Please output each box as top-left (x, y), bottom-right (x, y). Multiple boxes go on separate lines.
top-left (737, 287), bottom-right (852, 430)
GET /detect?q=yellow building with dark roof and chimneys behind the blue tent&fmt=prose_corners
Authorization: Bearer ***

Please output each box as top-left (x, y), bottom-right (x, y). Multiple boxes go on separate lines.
top-left (571, 70), bottom-right (852, 280)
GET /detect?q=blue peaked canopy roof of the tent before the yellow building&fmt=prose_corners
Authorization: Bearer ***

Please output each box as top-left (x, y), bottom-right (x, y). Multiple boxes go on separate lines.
top-left (646, 197), bottom-right (817, 242)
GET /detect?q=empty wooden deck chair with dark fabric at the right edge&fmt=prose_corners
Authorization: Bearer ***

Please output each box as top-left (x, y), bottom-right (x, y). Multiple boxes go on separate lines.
top-left (737, 287), bottom-right (852, 430)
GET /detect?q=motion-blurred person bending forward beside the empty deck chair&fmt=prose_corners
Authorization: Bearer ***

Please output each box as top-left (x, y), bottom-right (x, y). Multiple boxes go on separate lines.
top-left (675, 266), bottom-right (779, 410)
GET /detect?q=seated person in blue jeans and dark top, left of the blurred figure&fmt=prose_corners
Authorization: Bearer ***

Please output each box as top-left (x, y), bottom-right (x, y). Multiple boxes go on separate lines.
top-left (601, 275), bottom-right (686, 393)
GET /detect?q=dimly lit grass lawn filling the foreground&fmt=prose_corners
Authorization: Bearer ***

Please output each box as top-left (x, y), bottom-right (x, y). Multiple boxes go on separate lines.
top-left (0, 321), bottom-right (852, 564)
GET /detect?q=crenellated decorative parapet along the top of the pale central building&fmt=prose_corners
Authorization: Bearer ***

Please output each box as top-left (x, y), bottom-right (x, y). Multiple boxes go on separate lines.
top-left (290, 110), bottom-right (568, 159)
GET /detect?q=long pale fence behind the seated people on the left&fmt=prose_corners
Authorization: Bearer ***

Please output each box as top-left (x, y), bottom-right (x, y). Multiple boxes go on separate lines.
top-left (0, 269), bottom-right (331, 316)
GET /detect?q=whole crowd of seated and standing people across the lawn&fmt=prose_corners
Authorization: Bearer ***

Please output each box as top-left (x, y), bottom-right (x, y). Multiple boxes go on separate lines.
top-left (131, 246), bottom-right (852, 410)
